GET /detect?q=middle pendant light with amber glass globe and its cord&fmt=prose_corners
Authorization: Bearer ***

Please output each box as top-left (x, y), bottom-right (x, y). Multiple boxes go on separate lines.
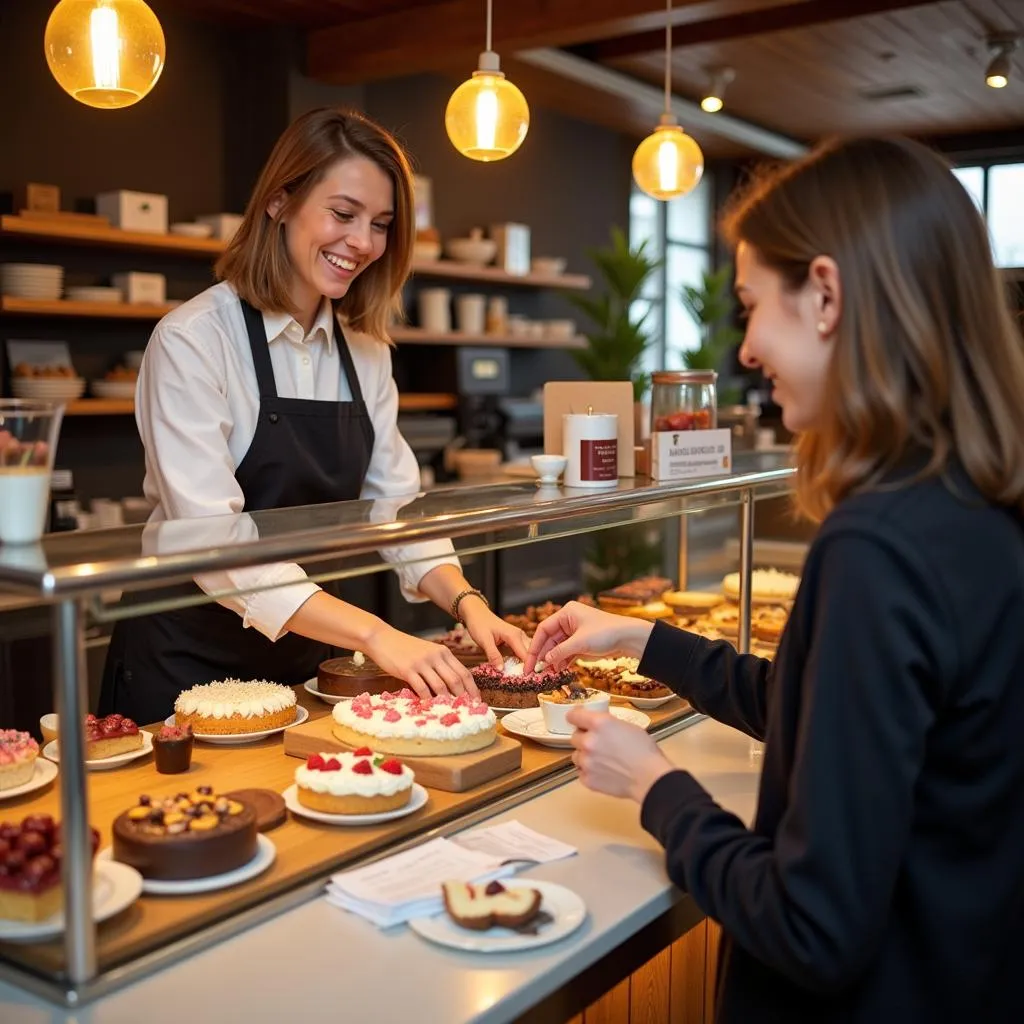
top-left (444, 0), bottom-right (529, 163)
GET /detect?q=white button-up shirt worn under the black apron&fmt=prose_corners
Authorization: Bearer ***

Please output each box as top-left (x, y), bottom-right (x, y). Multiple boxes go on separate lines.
top-left (135, 283), bottom-right (459, 640)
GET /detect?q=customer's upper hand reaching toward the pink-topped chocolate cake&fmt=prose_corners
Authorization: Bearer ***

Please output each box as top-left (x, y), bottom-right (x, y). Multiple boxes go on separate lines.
top-left (525, 601), bottom-right (653, 672)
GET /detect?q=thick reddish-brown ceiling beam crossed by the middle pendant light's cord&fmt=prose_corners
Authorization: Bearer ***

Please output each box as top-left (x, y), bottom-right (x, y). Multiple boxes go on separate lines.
top-left (306, 0), bottom-right (737, 85)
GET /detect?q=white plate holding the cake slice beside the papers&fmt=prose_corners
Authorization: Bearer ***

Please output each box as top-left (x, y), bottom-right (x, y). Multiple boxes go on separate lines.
top-left (409, 879), bottom-right (587, 953)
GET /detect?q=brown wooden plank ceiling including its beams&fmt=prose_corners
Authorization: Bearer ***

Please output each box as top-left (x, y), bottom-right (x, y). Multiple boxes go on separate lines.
top-left (172, 0), bottom-right (1024, 156)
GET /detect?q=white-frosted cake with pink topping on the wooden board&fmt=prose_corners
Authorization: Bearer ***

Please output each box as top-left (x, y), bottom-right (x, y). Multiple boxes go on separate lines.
top-left (333, 689), bottom-right (498, 757)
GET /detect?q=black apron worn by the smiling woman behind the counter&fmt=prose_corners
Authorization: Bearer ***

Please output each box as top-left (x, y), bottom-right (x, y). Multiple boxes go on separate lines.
top-left (99, 301), bottom-right (374, 723)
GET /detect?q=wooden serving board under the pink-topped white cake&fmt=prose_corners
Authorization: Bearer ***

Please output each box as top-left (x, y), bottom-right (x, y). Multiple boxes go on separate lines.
top-left (285, 715), bottom-right (522, 793)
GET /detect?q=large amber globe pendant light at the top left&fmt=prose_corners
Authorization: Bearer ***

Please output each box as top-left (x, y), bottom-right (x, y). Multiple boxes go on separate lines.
top-left (43, 0), bottom-right (166, 110)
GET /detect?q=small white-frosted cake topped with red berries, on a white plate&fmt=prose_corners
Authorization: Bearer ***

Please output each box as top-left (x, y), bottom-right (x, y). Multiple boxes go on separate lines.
top-left (295, 746), bottom-right (414, 814)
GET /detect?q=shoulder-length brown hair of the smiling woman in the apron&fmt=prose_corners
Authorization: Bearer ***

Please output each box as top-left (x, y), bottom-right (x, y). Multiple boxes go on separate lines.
top-left (216, 108), bottom-right (416, 341)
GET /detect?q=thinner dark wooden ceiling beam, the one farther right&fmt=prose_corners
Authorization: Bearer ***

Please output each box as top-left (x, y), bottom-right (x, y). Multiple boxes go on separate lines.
top-left (573, 0), bottom-right (941, 62)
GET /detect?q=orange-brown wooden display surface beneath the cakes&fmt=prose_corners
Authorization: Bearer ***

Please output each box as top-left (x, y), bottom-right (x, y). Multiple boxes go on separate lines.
top-left (0, 687), bottom-right (690, 976)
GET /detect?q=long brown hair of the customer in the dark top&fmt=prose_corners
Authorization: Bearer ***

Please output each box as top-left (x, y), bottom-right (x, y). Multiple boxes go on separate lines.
top-left (724, 138), bottom-right (1024, 519)
